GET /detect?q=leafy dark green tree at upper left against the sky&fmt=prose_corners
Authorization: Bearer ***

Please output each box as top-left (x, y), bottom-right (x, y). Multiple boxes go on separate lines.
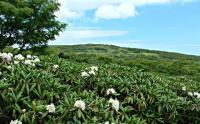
top-left (0, 0), bottom-right (66, 50)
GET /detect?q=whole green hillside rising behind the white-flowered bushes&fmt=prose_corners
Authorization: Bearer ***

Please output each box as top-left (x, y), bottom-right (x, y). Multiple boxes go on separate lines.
top-left (49, 44), bottom-right (200, 81)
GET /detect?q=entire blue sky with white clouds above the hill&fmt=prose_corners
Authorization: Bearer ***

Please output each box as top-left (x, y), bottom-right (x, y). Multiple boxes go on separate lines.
top-left (50, 0), bottom-right (200, 55)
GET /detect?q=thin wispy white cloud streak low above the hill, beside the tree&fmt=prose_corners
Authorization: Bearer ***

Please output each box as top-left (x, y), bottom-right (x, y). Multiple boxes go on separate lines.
top-left (50, 27), bottom-right (128, 45)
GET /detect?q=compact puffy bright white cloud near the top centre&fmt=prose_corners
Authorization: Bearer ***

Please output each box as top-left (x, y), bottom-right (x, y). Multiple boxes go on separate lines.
top-left (95, 3), bottom-right (137, 19)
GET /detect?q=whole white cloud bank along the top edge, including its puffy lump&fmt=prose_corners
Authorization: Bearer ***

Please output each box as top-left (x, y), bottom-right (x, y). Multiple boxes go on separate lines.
top-left (56, 0), bottom-right (196, 20)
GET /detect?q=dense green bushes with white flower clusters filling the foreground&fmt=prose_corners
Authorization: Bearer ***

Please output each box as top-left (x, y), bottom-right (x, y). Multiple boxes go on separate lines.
top-left (0, 54), bottom-right (200, 124)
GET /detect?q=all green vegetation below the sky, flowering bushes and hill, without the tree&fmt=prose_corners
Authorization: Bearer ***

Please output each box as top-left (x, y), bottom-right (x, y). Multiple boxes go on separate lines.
top-left (0, 45), bottom-right (200, 124)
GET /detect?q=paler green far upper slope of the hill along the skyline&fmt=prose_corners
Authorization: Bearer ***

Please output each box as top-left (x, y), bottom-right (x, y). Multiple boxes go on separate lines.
top-left (51, 44), bottom-right (200, 61)
